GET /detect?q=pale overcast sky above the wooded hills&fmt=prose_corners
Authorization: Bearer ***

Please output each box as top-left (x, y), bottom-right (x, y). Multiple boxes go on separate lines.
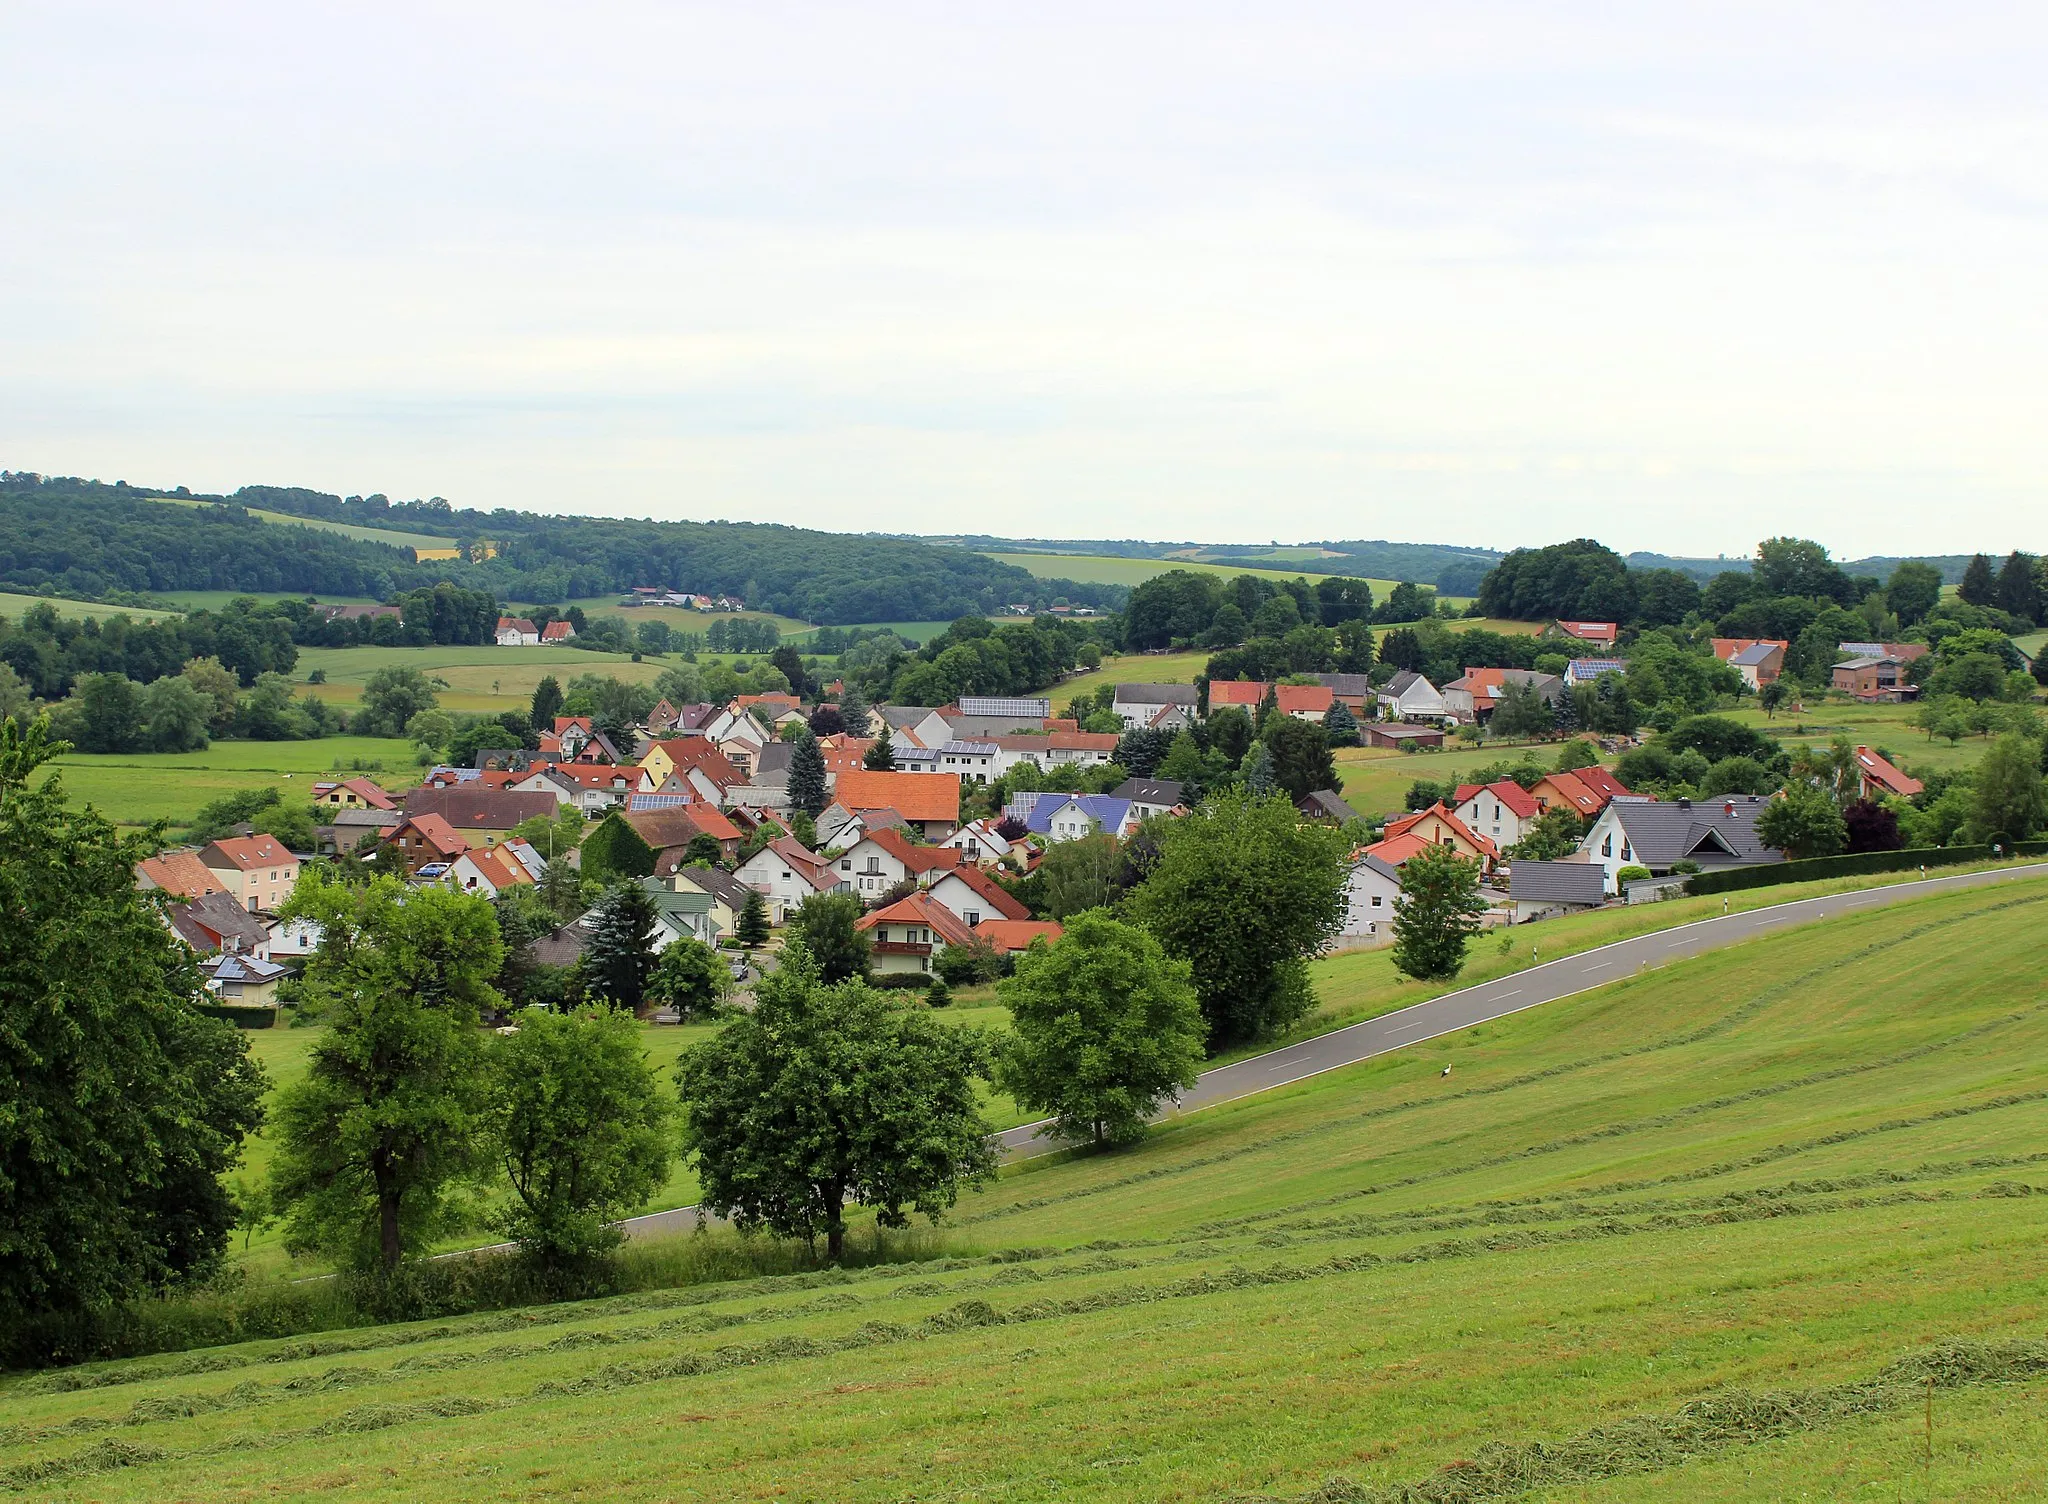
top-left (0, 0), bottom-right (2048, 557)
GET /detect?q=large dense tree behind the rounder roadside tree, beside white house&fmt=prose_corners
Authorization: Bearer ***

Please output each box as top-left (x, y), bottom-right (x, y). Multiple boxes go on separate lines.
top-left (1124, 791), bottom-right (1348, 1049)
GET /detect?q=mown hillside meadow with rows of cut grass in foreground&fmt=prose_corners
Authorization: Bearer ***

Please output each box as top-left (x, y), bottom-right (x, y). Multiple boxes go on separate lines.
top-left (16, 881), bottom-right (2048, 1500)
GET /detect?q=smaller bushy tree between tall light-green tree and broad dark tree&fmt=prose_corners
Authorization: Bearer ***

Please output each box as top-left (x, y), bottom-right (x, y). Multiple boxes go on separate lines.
top-left (483, 1008), bottom-right (675, 1279)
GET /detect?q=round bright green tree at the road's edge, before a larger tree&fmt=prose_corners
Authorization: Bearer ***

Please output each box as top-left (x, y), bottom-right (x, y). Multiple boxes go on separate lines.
top-left (995, 910), bottom-right (1206, 1145)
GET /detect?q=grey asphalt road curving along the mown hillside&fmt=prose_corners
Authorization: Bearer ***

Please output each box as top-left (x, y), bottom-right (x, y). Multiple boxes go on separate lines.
top-left (623, 863), bottom-right (2048, 1236)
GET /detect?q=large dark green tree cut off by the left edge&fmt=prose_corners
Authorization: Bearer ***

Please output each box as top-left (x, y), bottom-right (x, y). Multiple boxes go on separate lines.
top-left (0, 719), bottom-right (266, 1334)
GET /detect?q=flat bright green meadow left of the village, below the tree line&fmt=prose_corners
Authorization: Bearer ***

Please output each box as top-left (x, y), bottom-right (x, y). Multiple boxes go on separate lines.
top-left (53, 736), bottom-right (420, 826)
